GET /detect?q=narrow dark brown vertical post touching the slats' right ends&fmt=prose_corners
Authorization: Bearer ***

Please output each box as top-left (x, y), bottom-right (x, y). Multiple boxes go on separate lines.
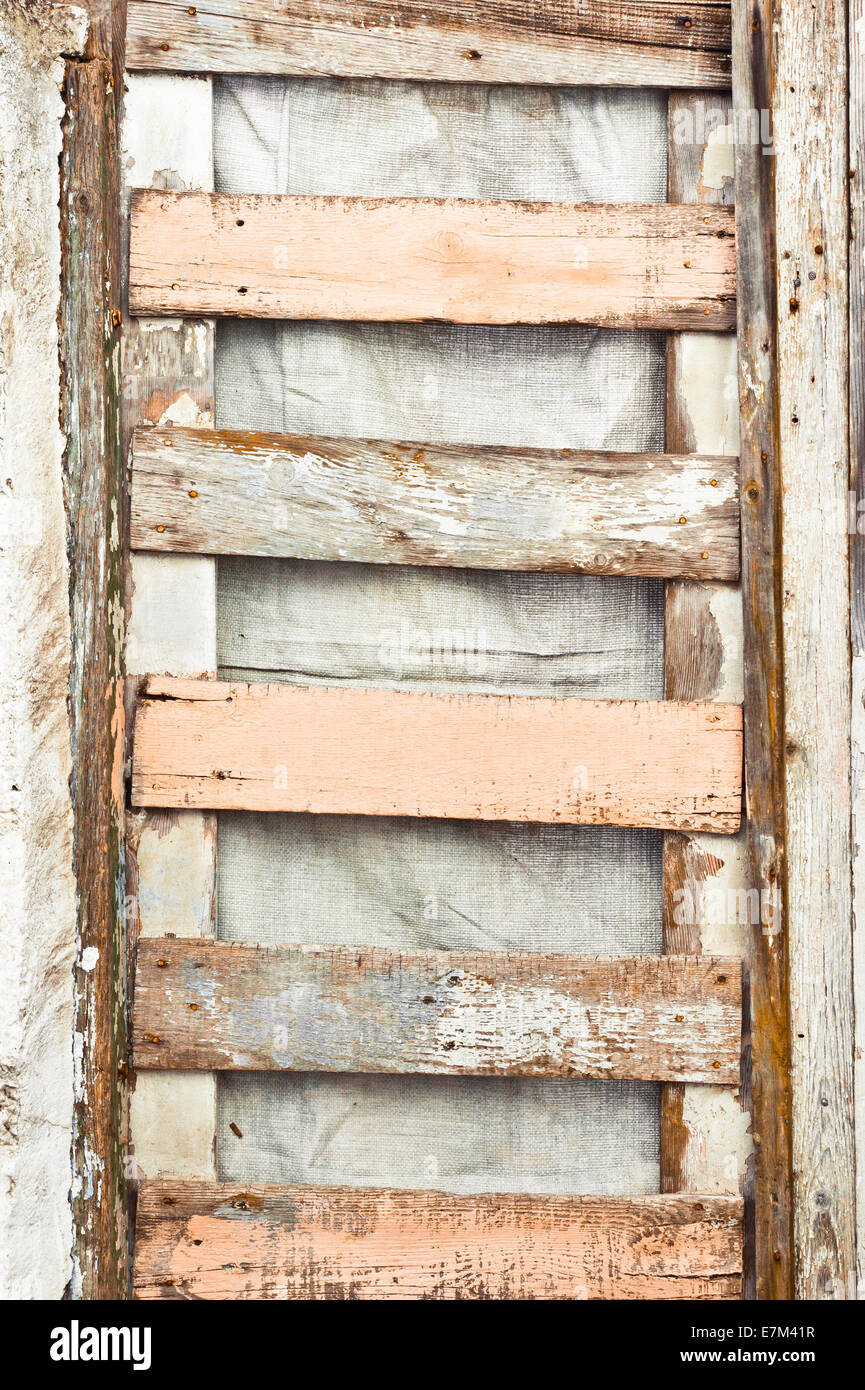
top-left (733, 0), bottom-right (795, 1301)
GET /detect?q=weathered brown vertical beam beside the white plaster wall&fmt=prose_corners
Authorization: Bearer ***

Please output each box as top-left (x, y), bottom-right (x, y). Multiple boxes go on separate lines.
top-left (61, 57), bottom-right (128, 1298)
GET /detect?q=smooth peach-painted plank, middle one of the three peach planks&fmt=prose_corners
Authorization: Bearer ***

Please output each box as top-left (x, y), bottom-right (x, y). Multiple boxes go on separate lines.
top-left (132, 677), bottom-right (741, 833)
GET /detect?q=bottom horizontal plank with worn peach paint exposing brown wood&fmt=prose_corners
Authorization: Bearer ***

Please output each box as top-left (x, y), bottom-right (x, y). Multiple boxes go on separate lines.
top-left (135, 1183), bottom-right (741, 1300)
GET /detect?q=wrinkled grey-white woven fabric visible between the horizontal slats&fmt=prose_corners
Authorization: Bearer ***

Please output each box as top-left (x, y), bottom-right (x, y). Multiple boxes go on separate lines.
top-left (214, 79), bottom-right (666, 1193)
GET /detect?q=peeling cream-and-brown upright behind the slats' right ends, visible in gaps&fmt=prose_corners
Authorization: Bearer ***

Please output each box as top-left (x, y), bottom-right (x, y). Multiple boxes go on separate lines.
top-left (661, 93), bottom-right (751, 1251)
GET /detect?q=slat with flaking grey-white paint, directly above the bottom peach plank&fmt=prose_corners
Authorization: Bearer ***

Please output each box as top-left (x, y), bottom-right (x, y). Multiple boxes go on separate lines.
top-left (134, 938), bottom-right (741, 1084)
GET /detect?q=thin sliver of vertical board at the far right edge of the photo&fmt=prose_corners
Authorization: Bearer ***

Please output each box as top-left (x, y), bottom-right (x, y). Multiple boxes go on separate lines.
top-left (847, 0), bottom-right (865, 1298)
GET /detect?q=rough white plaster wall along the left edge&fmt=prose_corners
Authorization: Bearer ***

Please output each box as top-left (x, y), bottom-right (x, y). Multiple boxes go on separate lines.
top-left (0, 0), bottom-right (86, 1298)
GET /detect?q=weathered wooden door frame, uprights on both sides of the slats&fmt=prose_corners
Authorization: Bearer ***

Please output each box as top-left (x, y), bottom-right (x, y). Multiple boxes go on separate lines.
top-left (49, 0), bottom-right (865, 1300)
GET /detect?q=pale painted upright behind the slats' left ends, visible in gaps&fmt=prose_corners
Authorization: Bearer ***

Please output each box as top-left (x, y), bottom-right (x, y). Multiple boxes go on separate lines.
top-left (122, 75), bottom-right (216, 1177)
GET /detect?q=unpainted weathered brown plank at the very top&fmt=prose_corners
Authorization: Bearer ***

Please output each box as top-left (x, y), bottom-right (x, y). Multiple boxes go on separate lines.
top-left (128, 0), bottom-right (730, 90)
